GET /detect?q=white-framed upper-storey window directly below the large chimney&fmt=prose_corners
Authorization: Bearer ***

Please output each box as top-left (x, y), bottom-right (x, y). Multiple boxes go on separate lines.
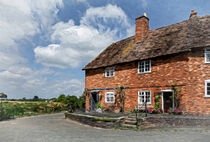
top-left (138, 60), bottom-right (151, 73)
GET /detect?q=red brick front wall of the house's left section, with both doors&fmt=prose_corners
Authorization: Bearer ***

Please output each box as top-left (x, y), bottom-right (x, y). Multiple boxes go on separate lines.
top-left (85, 53), bottom-right (193, 111)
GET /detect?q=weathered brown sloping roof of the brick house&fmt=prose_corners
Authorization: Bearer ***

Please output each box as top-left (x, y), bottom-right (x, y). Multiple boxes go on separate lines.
top-left (83, 15), bottom-right (210, 70)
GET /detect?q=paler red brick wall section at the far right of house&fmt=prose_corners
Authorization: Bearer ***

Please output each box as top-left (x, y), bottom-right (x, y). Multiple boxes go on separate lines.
top-left (186, 50), bottom-right (210, 114)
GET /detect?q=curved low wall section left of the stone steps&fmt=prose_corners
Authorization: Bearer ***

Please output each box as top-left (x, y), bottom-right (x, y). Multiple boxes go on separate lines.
top-left (65, 112), bottom-right (124, 128)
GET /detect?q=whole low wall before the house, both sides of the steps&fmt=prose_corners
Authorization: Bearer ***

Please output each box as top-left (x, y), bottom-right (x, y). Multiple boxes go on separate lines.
top-left (65, 113), bottom-right (210, 128)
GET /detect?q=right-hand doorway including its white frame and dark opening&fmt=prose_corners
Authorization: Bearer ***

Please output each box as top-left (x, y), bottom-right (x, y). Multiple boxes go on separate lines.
top-left (162, 90), bottom-right (174, 113)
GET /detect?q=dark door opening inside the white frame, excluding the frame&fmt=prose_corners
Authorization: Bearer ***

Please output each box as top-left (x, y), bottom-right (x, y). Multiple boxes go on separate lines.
top-left (163, 92), bottom-right (173, 113)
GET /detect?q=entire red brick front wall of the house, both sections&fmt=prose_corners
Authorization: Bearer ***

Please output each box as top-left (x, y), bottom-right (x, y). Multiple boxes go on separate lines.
top-left (85, 50), bottom-right (210, 114)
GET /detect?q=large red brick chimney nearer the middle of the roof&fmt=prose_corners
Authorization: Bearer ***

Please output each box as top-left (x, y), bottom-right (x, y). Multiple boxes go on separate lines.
top-left (135, 13), bottom-right (149, 42)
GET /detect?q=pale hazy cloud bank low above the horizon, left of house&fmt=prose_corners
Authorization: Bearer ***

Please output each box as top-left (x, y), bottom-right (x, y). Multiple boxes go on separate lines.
top-left (0, 63), bottom-right (84, 98)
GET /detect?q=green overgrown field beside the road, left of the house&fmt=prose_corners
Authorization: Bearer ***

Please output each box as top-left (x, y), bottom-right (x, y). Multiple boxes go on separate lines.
top-left (0, 101), bottom-right (66, 120)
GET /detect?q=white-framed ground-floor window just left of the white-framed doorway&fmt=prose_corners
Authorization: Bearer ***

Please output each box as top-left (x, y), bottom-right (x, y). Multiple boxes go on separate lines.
top-left (138, 91), bottom-right (151, 104)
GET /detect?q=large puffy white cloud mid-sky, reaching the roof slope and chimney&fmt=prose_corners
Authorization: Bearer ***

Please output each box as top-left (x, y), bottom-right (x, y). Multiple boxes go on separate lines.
top-left (34, 4), bottom-right (134, 68)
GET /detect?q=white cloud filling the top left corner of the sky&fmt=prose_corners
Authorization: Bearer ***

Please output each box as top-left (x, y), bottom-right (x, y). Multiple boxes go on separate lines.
top-left (0, 0), bottom-right (62, 48)
